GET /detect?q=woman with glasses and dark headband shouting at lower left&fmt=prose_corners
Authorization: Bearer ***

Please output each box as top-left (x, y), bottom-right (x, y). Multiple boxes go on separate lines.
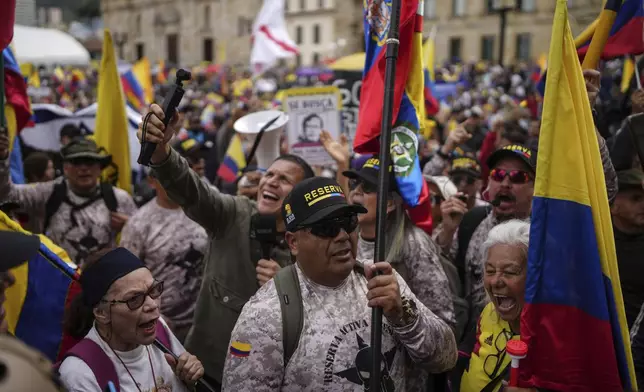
top-left (59, 248), bottom-right (204, 392)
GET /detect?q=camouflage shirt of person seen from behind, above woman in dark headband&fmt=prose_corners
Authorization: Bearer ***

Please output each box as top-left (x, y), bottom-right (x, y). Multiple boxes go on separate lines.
top-left (121, 198), bottom-right (208, 339)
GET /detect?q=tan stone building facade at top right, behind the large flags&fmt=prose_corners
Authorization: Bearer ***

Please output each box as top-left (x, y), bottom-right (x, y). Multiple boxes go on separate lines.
top-left (424, 0), bottom-right (603, 64)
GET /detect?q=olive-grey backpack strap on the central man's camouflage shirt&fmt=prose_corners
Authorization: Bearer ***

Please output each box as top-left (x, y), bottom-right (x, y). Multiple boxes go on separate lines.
top-left (273, 264), bottom-right (304, 367)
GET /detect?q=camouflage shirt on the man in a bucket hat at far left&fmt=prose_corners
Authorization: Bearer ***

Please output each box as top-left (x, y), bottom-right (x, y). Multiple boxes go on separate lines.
top-left (0, 161), bottom-right (136, 265)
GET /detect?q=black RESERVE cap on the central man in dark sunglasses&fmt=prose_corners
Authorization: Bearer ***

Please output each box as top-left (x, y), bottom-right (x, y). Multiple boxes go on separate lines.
top-left (282, 177), bottom-right (367, 232)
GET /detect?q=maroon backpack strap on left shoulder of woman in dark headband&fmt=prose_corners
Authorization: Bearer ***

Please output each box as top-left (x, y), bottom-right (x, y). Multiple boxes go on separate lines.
top-left (54, 338), bottom-right (121, 391)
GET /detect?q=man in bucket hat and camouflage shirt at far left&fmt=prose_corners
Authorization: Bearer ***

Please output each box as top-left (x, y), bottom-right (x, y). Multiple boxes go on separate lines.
top-left (0, 136), bottom-right (136, 265)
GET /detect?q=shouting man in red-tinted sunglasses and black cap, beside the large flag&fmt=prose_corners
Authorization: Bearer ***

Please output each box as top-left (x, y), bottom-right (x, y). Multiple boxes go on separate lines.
top-left (435, 140), bottom-right (617, 346)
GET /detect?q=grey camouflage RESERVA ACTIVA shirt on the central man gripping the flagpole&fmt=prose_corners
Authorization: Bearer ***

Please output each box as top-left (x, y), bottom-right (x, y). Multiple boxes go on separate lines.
top-left (222, 266), bottom-right (457, 392)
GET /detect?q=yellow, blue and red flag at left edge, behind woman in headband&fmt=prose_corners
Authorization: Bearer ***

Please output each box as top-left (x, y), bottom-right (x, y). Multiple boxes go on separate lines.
top-left (0, 211), bottom-right (80, 362)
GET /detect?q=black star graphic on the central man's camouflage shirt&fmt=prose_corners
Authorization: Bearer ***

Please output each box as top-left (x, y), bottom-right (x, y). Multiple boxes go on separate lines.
top-left (335, 333), bottom-right (396, 392)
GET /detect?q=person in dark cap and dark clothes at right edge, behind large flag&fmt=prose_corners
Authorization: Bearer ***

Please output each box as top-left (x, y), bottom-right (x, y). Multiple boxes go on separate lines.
top-left (610, 169), bottom-right (644, 327)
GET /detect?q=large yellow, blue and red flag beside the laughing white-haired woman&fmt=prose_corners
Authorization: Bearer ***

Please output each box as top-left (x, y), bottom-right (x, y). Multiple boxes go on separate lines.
top-left (520, 0), bottom-right (636, 392)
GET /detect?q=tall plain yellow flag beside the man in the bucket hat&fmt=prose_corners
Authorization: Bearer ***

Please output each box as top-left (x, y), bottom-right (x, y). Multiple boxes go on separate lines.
top-left (94, 29), bottom-right (132, 193)
